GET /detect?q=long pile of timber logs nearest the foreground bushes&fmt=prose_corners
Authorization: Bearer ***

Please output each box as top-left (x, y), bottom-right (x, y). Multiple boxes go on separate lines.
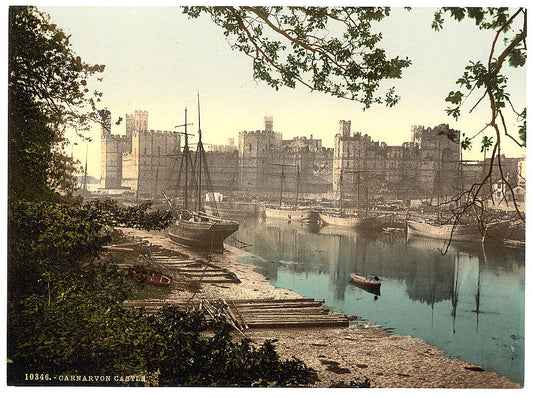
top-left (123, 298), bottom-right (349, 330)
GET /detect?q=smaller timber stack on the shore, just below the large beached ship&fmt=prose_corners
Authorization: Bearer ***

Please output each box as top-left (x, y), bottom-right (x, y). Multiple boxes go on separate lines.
top-left (152, 253), bottom-right (241, 283)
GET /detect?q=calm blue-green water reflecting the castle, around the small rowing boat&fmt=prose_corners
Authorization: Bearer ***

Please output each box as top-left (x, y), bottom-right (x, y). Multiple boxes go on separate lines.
top-left (230, 216), bottom-right (525, 384)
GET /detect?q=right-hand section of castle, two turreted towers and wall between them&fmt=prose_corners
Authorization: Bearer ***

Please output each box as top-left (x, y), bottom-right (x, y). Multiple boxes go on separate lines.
top-left (333, 120), bottom-right (461, 203)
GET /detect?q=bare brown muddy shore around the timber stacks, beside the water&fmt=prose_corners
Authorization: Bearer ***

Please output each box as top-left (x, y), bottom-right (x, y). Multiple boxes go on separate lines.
top-left (119, 228), bottom-right (523, 389)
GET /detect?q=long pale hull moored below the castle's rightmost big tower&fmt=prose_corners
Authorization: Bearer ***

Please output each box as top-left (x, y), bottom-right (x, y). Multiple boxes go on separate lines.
top-left (407, 220), bottom-right (483, 242)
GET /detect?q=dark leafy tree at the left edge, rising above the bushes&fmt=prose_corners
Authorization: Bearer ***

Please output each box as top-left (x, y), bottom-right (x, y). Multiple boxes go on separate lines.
top-left (8, 7), bottom-right (104, 198)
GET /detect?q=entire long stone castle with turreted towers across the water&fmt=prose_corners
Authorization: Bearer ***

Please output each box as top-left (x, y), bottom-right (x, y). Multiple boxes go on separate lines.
top-left (101, 111), bottom-right (516, 204)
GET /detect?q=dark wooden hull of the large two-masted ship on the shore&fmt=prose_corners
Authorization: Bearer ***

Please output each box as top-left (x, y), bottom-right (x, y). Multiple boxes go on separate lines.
top-left (168, 219), bottom-right (239, 253)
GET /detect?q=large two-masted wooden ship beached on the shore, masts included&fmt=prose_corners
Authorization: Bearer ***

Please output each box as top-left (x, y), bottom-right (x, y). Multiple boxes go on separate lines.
top-left (168, 95), bottom-right (239, 253)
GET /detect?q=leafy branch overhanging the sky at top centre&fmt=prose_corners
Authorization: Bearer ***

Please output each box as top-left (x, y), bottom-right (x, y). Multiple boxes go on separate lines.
top-left (183, 6), bottom-right (411, 108)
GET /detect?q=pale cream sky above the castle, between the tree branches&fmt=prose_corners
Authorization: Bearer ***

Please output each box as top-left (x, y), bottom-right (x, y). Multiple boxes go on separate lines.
top-left (38, 3), bottom-right (526, 177)
